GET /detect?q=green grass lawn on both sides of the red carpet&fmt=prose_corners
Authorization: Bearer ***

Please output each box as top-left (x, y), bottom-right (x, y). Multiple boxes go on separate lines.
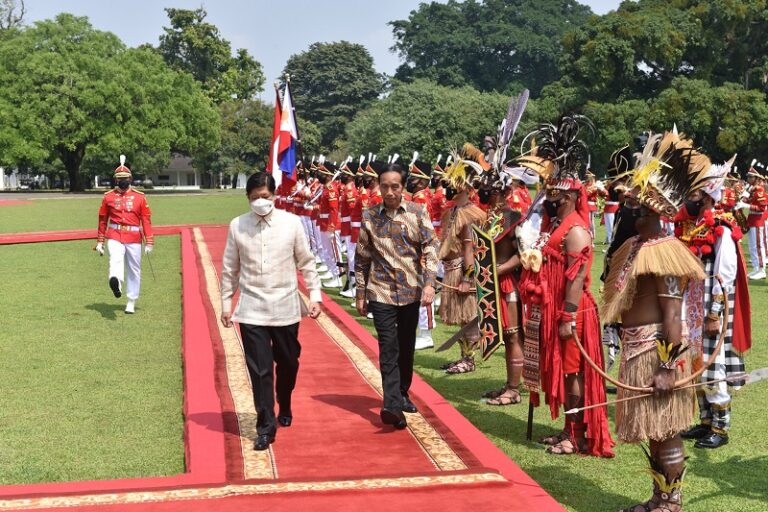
top-left (0, 191), bottom-right (768, 512)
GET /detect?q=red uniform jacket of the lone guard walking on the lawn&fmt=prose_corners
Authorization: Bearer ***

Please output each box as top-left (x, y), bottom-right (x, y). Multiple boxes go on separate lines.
top-left (97, 188), bottom-right (155, 245)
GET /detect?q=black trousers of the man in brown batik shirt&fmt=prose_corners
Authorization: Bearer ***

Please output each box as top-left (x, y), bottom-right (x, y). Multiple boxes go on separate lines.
top-left (368, 302), bottom-right (420, 410)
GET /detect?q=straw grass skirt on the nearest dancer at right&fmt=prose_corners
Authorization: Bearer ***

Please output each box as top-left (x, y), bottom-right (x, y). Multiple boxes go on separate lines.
top-left (616, 324), bottom-right (695, 443)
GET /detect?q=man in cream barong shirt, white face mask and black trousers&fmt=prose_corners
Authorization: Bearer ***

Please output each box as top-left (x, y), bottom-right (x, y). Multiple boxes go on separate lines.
top-left (221, 172), bottom-right (321, 450)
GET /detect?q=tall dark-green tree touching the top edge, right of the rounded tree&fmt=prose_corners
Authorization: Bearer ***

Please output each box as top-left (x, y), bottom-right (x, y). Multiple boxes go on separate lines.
top-left (390, 0), bottom-right (592, 96)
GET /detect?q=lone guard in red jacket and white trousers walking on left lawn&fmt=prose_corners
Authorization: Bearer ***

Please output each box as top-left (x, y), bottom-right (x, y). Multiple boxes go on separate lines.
top-left (94, 155), bottom-right (155, 314)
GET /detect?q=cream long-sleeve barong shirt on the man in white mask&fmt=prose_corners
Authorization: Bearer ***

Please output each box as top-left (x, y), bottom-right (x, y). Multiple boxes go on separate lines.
top-left (221, 209), bottom-right (321, 326)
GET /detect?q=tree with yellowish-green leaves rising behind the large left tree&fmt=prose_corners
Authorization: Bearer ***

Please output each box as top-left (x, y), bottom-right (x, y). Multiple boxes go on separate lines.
top-left (158, 7), bottom-right (264, 104)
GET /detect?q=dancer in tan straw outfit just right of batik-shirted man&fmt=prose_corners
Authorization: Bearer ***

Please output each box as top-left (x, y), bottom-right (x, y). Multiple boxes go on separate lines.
top-left (439, 144), bottom-right (489, 374)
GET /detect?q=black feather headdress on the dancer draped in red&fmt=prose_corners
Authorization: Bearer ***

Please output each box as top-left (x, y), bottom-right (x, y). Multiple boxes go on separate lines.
top-left (518, 115), bottom-right (594, 190)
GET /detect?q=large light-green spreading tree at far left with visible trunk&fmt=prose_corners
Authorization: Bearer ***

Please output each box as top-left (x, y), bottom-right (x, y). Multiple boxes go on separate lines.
top-left (0, 14), bottom-right (218, 191)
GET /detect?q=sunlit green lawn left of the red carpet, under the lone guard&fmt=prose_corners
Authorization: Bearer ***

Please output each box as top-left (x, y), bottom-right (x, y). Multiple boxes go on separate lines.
top-left (0, 236), bottom-right (184, 484)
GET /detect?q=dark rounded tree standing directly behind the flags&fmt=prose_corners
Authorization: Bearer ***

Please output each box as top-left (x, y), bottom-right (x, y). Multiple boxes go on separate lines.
top-left (284, 41), bottom-right (383, 152)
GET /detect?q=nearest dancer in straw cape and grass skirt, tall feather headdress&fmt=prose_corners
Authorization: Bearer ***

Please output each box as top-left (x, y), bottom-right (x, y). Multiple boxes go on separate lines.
top-left (603, 133), bottom-right (708, 512)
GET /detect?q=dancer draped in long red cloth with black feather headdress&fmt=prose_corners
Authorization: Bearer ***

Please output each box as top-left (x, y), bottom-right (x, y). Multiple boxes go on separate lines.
top-left (519, 116), bottom-right (614, 457)
